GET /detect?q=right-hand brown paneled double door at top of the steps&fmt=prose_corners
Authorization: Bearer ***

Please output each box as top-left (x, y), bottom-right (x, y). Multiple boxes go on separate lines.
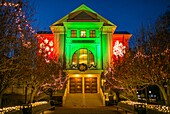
top-left (84, 77), bottom-right (97, 93)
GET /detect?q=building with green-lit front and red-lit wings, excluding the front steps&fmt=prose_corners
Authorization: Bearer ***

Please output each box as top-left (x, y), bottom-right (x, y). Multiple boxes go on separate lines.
top-left (38, 4), bottom-right (131, 106)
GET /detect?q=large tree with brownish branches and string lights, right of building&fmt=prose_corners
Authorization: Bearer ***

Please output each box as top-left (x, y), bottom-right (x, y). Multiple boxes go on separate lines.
top-left (107, 11), bottom-right (170, 105)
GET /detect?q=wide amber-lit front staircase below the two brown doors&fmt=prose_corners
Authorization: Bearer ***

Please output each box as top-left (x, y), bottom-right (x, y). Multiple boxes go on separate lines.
top-left (64, 93), bottom-right (103, 108)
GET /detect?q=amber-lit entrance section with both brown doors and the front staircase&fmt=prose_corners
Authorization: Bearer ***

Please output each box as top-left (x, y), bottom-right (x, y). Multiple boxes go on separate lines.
top-left (63, 70), bottom-right (105, 107)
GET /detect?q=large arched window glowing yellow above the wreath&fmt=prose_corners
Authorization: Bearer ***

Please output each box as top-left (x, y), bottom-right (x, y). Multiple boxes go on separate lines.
top-left (72, 49), bottom-right (94, 65)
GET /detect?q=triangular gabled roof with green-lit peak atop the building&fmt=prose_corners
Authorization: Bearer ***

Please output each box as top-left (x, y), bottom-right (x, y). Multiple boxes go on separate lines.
top-left (51, 4), bottom-right (116, 26)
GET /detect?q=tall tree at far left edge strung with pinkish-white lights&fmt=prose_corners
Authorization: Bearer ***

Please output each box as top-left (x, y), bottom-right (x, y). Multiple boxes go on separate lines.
top-left (0, 0), bottom-right (35, 104)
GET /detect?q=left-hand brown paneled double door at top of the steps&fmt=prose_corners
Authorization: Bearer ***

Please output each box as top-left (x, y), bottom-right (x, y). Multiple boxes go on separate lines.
top-left (70, 77), bottom-right (82, 93)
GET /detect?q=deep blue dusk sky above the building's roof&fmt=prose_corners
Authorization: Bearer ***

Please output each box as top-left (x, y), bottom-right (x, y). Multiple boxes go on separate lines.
top-left (30, 0), bottom-right (170, 34)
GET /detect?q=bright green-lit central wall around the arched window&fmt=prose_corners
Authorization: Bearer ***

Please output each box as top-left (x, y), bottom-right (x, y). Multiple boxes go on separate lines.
top-left (64, 22), bottom-right (103, 69)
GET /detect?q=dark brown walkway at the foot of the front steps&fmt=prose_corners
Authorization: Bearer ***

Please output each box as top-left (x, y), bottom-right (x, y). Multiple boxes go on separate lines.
top-left (44, 106), bottom-right (125, 114)
